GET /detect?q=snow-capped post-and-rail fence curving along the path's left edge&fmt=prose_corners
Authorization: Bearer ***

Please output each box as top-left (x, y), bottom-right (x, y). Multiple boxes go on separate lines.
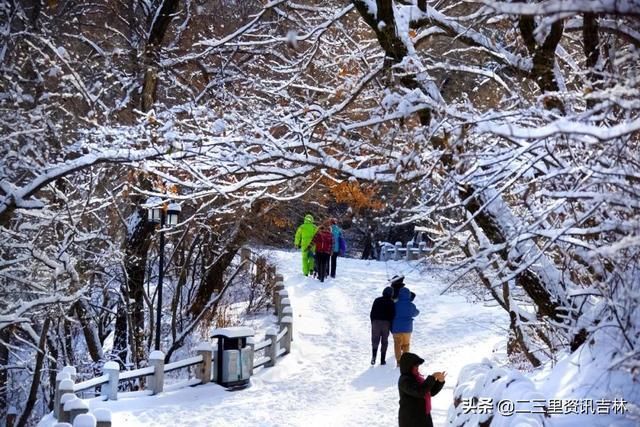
top-left (46, 248), bottom-right (293, 427)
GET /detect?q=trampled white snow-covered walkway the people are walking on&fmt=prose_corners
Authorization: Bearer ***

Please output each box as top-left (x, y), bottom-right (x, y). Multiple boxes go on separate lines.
top-left (41, 252), bottom-right (507, 427)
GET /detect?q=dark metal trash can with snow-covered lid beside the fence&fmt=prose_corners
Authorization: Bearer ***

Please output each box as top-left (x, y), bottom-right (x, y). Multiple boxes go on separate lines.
top-left (211, 326), bottom-right (255, 389)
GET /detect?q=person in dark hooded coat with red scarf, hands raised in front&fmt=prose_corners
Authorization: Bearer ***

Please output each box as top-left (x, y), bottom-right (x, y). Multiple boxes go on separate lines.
top-left (398, 353), bottom-right (447, 427)
